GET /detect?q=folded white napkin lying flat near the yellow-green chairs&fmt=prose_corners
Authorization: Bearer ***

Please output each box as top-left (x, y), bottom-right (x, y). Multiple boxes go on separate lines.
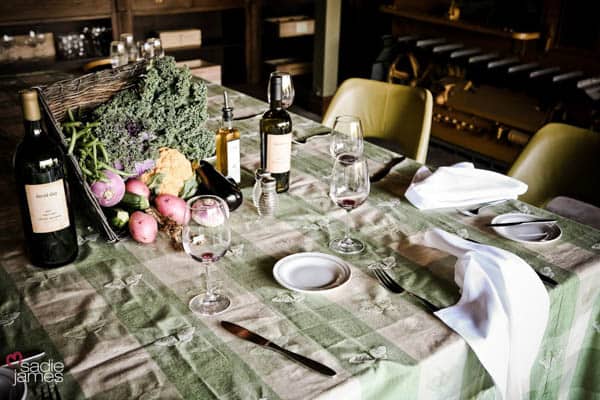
top-left (405, 162), bottom-right (527, 210)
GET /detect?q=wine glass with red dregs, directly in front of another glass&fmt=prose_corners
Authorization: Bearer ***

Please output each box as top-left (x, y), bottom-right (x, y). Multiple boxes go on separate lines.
top-left (329, 153), bottom-right (371, 254)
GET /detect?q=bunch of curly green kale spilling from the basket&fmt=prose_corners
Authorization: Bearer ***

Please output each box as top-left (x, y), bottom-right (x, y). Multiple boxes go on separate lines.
top-left (93, 57), bottom-right (215, 172)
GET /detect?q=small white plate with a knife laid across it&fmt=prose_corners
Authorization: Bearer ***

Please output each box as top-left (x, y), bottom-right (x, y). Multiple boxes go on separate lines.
top-left (492, 213), bottom-right (562, 243)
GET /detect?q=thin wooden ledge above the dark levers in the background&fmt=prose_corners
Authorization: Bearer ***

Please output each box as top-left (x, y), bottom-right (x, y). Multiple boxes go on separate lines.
top-left (380, 6), bottom-right (541, 41)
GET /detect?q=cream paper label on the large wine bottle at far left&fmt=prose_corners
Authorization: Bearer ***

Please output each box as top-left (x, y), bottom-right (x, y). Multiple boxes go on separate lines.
top-left (25, 179), bottom-right (70, 233)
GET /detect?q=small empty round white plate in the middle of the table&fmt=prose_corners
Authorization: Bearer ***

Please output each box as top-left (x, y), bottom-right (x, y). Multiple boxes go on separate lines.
top-left (273, 253), bottom-right (352, 293)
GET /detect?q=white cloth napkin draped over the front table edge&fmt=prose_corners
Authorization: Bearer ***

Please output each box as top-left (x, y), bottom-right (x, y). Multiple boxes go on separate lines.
top-left (425, 229), bottom-right (550, 400)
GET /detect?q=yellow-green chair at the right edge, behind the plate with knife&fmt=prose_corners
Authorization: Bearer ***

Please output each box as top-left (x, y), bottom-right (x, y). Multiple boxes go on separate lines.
top-left (508, 123), bottom-right (600, 207)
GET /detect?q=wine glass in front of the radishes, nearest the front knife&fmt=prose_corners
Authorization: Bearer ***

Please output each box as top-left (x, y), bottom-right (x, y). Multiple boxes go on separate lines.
top-left (181, 196), bottom-right (231, 315)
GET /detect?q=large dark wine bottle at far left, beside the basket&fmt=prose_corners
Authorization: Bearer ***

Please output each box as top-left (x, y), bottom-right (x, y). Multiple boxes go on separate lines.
top-left (14, 90), bottom-right (78, 268)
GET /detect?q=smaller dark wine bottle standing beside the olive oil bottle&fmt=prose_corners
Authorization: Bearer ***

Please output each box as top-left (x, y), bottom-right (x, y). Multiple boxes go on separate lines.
top-left (260, 75), bottom-right (292, 193)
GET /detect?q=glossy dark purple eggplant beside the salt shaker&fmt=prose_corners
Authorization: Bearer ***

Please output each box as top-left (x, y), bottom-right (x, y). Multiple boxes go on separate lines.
top-left (196, 160), bottom-right (244, 211)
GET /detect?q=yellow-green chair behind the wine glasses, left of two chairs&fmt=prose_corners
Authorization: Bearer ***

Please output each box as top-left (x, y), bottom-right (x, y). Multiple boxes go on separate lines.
top-left (323, 78), bottom-right (433, 163)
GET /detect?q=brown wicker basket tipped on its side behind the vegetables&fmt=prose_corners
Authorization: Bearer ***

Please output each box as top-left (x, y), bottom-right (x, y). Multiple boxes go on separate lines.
top-left (36, 61), bottom-right (146, 242)
